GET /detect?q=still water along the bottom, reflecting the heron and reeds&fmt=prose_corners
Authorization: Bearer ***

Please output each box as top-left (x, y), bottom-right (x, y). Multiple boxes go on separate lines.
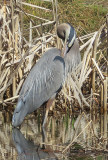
top-left (0, 111), bottom-right (108, 160)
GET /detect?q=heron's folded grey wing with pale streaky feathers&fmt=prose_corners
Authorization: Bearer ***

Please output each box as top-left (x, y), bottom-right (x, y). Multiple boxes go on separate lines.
top-left (20, 49), bottom-right (65, 107)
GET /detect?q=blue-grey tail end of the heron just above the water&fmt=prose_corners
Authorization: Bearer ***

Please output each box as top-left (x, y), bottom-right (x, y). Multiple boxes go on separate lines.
top-left (12, 99), bottom-right (27, 127)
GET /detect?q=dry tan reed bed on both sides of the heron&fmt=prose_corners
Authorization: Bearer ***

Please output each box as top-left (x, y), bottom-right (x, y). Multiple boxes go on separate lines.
top-left (0, 1), bottom-right (107, 110)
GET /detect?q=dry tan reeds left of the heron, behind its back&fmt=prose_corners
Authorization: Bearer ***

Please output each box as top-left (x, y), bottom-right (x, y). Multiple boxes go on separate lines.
top-left (0, 1), bottom-right (55, 104)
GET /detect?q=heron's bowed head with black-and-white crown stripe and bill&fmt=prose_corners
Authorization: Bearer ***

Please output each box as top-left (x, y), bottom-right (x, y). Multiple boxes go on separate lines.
top-left (57, 23), bottom-right (76, 52)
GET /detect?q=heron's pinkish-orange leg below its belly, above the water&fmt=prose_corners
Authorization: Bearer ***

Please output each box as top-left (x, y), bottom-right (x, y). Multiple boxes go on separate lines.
top-left (42, 98), bottom-right (54, 127)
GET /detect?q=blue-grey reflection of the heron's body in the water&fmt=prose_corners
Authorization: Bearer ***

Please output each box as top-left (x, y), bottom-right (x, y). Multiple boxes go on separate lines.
top-left (12, 129), bottom-right (57, 160)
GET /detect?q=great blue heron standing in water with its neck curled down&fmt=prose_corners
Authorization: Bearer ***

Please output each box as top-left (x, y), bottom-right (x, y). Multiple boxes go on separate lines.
top-left (12, 23), bottom-right (81, 127)
